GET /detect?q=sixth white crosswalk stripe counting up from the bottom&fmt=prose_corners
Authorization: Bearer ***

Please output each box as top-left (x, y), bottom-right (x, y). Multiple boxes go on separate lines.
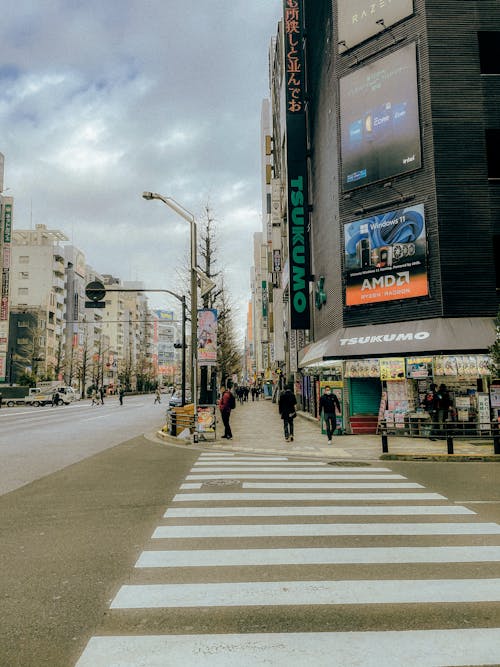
top-left (173, 491), bottom-right (447, 503)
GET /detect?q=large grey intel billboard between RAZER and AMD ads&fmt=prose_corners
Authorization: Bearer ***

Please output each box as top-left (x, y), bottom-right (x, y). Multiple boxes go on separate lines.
top-left (340, 44), bottom-right (422, 191)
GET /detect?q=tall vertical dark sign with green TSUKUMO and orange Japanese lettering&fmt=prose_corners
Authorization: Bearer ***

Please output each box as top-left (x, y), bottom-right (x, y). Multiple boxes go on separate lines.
top-left (283, 0), bottom-right (310, 329)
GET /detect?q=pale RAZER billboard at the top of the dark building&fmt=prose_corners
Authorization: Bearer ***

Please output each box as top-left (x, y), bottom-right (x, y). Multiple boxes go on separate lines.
top-left (337, 0), bottom-right (413, 53)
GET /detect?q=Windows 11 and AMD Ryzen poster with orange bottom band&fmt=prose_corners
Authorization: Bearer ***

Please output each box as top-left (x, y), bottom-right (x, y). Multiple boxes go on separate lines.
top-left (344, 204), bottom-right (429, 306)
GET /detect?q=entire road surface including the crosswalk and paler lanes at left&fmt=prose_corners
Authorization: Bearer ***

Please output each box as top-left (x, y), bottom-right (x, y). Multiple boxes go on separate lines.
top-left (0, 397), bottom-right (500, 667)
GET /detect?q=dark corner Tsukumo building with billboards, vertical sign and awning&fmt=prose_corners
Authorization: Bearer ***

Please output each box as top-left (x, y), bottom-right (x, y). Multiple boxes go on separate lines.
top-left (270, 0), bottom-right (500, 431)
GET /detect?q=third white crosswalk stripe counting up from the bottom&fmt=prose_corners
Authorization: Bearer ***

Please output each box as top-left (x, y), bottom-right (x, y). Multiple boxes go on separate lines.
top-left (135, 546), bottom-right (500, 568)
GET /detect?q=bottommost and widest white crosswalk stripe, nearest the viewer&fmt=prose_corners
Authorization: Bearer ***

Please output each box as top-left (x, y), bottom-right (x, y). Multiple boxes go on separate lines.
top-left (76, 628), bottom-right (500, 667)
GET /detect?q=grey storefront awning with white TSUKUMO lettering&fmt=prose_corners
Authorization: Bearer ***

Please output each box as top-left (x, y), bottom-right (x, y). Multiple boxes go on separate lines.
top-left (299, 317), bottom-right (495, 368)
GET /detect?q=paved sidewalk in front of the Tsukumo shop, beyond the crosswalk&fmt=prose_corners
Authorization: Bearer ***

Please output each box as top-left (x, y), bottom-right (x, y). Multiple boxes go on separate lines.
top-left (157, 398), bottom-right (500, 461)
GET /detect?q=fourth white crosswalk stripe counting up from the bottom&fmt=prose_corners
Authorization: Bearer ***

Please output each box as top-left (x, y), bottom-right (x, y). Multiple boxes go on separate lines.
top-left (152, 523), bottom-right (500, 539)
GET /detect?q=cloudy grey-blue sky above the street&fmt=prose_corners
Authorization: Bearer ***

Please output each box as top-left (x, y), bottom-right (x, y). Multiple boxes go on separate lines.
top-left (0, 0), bottom-right (282, 334)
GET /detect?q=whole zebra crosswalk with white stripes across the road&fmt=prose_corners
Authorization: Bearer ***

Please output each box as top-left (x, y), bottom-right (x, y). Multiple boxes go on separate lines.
top-left (76, 452), bottom-right (500, 667)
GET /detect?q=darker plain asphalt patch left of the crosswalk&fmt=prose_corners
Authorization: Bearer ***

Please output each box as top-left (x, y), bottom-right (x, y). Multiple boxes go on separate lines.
top-left (0, 411), bottom-right (196, 667)
